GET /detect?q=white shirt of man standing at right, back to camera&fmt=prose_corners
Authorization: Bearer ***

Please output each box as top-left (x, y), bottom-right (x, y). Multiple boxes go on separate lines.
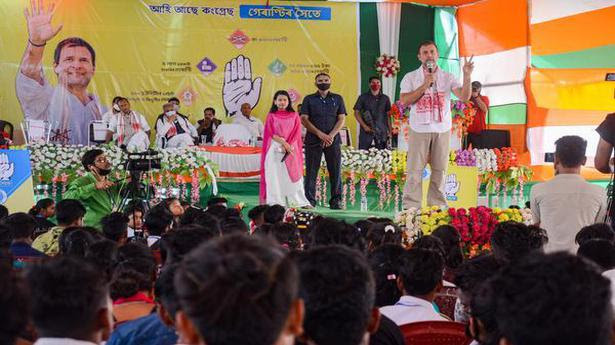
top-left (530, 174), bottom-right (607, 254)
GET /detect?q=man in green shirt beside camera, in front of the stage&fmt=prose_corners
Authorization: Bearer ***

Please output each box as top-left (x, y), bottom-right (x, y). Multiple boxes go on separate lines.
top-left (63, 149), bottom-right (121, 229)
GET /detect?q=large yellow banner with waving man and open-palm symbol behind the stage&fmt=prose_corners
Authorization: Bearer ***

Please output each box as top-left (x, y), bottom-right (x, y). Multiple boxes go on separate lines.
top-left (0, 0), bottom-right (358, 144)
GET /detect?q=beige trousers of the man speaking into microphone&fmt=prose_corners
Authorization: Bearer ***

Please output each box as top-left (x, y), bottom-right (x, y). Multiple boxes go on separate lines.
top-left (403, 128), bottom-right (451, 209)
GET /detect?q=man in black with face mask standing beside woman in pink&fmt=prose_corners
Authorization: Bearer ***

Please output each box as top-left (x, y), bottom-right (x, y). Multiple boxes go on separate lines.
top-left (301, 73), bottom-right (346, 209)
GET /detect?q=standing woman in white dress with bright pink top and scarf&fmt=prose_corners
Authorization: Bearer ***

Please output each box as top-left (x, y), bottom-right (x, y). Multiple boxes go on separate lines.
top-left (259, 90), bottom-right (311, 207)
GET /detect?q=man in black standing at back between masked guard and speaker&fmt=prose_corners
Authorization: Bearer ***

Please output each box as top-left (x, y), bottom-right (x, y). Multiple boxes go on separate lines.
top-left (354, 77), bottom-right (391, 150)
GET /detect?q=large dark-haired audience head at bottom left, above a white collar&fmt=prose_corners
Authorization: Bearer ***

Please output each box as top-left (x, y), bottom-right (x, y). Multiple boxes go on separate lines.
top-left (26, 257), bottom-right (113, 345)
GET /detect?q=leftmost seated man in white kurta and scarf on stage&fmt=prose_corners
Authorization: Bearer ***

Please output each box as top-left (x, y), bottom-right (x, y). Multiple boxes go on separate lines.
top-left (107, 98), bottom-right (150, 152)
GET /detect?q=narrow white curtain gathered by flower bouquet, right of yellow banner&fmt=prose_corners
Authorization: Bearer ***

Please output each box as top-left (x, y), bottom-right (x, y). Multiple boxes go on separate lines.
top-left (377, 2), bottom-right (401, 102)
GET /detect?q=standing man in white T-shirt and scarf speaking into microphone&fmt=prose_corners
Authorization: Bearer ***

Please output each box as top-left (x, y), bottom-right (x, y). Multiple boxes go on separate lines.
top-left (400, 41), bottom-right (474, 209)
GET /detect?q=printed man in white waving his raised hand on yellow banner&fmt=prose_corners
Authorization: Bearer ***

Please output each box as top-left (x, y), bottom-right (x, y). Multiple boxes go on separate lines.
top-left (16, 0), bottom-right (105, 145)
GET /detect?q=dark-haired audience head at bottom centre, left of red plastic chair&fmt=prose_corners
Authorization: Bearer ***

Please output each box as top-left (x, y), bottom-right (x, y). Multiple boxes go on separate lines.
top-left (294, 245), bottom-right (380, 345)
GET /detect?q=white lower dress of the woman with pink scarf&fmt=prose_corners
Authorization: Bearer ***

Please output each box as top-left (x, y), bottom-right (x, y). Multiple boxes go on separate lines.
top-left (265, 140), bottom-right (310, 207)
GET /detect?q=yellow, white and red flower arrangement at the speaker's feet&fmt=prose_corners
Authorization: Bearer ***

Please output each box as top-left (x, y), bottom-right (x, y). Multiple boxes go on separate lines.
top-left (395, 206), bottom-right (532, 257)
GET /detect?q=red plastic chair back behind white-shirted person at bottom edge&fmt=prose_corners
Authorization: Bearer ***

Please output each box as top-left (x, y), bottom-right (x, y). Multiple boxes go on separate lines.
top-left (399, 321), bottom-right (472, 345)
